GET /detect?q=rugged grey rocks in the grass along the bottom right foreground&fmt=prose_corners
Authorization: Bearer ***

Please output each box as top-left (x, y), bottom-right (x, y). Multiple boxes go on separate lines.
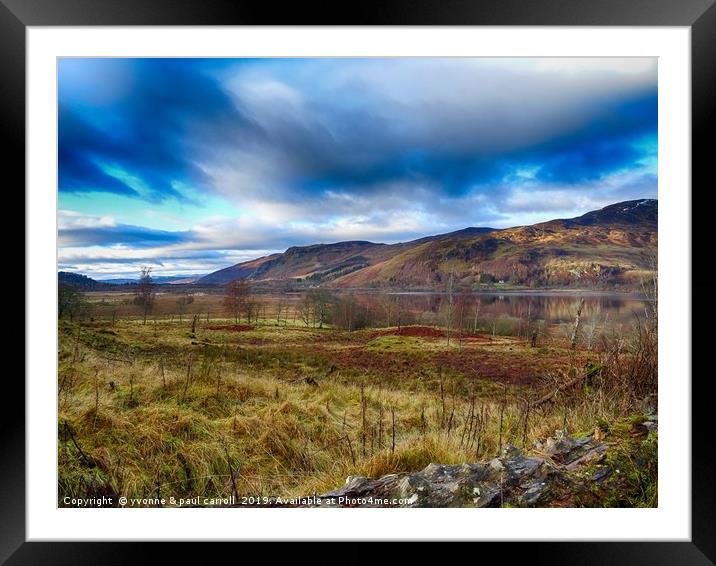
top-left (310, 422), bottom-right (656, 507)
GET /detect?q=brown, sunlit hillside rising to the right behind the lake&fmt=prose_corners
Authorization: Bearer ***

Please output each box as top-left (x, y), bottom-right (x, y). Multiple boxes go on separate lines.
top-left (198, 199), bottom-right (658, 289)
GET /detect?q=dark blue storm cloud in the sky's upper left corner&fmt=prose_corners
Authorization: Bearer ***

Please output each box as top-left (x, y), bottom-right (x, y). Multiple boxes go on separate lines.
top-left (58, 59), bottom-right (258, 202)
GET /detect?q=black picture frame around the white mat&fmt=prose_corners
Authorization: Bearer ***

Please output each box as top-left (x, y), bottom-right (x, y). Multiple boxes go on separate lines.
top-left (0, 0), bottom-right (716, 565)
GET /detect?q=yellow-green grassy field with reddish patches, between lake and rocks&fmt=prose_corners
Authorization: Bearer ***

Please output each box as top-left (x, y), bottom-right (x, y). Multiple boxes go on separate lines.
top-left (58, 294), bottom-right (656, 504)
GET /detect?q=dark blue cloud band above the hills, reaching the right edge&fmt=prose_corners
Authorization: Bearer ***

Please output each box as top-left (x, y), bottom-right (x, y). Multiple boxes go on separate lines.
top-left (260, 90), bottom-right (657, 197)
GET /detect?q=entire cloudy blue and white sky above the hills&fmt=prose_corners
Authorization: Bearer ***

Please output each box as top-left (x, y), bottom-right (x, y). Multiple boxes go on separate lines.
top-left (58, 58), bottom-right (657, 279)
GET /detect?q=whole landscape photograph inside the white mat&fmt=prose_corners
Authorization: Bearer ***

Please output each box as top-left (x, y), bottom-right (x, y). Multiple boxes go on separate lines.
top-left (58, 57), bottom-right (656, 508)
